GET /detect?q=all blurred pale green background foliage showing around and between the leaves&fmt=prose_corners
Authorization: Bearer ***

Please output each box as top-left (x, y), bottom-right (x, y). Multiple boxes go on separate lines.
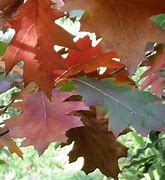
top-left (0, 12), bottom-right (165, 180)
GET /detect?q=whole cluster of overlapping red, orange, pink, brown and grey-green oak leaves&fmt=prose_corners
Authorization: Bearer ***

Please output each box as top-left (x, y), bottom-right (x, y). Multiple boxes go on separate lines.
top-left (0, 0), bottom-right (165, 179)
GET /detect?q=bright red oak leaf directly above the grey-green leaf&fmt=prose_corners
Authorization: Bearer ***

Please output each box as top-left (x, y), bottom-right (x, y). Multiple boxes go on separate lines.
top-left (54, 36), bottom-right (134, 84)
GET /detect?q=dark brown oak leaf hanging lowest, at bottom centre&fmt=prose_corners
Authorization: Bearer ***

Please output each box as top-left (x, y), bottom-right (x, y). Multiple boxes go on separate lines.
top-left (66, 111), bottom-right (127, 179)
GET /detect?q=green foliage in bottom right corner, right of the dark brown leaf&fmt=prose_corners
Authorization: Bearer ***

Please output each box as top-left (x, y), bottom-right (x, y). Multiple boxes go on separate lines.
top-left (118, 132), bottom-right (165, 180)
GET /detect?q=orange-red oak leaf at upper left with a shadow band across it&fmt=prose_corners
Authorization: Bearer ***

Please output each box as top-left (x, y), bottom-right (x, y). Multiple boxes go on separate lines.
top-left (4, 0), bottom-right (76, 96)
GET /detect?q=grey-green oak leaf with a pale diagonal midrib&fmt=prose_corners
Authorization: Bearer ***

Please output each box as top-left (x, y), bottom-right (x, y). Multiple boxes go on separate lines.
top-left (74, 78), bottom-right (165, 135)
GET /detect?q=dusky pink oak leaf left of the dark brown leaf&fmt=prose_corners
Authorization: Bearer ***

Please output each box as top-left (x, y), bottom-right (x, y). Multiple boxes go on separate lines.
top-left (6, 90), bottom-right (88, 154)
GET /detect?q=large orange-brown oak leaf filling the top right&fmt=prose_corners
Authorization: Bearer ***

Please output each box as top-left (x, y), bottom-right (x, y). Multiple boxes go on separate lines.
top-left (59, 0), bottom-right (165, 73)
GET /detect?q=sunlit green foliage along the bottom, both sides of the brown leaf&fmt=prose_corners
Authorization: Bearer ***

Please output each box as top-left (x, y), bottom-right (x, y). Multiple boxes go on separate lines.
top-left (0, 129), bottom-right (165, 180)
